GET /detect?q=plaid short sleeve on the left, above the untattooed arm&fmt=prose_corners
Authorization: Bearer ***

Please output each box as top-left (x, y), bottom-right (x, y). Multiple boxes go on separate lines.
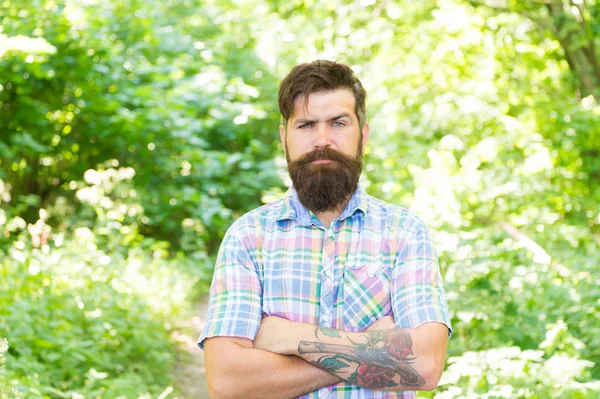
top-left (198, 231), bottom-right (262, 350)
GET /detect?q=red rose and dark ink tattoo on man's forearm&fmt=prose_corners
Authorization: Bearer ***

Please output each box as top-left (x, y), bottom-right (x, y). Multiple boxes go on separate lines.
top-left (298, 327), bottom-right (425, 389)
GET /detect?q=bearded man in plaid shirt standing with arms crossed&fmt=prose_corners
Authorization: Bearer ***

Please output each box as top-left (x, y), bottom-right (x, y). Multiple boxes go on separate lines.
top-left (198, 61), bottom-right (451, 399)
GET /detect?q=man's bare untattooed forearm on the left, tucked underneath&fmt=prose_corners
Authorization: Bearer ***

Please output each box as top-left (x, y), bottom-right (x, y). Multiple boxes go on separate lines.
top-left (205, 338), bottom-right (341, 399)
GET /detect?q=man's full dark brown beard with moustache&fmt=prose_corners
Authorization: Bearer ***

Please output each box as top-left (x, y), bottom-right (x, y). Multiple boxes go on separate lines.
top-left (286, 145), bottom-right (363, 212)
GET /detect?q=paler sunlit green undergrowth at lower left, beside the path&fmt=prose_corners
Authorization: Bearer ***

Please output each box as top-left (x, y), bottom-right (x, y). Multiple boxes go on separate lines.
top-left (0, 173), bottom-right (201, 398)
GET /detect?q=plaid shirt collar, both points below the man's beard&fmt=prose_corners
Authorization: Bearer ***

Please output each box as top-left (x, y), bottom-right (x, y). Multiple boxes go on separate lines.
top-left (277, 184), bottom-right (369, 226)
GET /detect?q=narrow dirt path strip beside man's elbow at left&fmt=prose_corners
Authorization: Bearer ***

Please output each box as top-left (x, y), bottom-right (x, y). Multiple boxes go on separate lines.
top-left (173, 299), bottom-right (209, 399)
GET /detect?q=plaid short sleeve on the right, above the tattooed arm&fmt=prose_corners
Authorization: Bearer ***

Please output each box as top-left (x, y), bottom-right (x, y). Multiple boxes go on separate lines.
top-left (391, 228), bottom-right (452, 336)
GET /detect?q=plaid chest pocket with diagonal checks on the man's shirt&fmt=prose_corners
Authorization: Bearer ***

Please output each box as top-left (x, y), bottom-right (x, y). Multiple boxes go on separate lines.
top-left (343, 261), bottom-right (392, 331)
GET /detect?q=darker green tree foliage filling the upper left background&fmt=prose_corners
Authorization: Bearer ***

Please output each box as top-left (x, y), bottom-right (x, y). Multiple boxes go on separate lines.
top-left (0, 1), bottom-right (277, 251)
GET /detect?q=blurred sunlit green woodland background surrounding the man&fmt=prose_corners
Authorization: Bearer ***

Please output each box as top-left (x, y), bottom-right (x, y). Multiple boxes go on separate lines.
top-left (0, 0), bottom-right (600, 399)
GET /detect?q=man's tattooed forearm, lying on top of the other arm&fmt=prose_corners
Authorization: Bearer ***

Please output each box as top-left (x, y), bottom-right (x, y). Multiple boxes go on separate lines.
top-left (255, 320), bottom-right (447, 391)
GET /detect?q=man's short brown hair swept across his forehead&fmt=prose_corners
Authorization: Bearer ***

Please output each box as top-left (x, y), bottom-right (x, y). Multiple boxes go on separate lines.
top-left (278, 60), bottom-right (367, 128)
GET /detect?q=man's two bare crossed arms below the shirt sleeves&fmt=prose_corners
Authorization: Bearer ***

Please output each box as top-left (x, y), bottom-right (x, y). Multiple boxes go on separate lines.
top-left (205, 316), bottom-right (448, 398)
